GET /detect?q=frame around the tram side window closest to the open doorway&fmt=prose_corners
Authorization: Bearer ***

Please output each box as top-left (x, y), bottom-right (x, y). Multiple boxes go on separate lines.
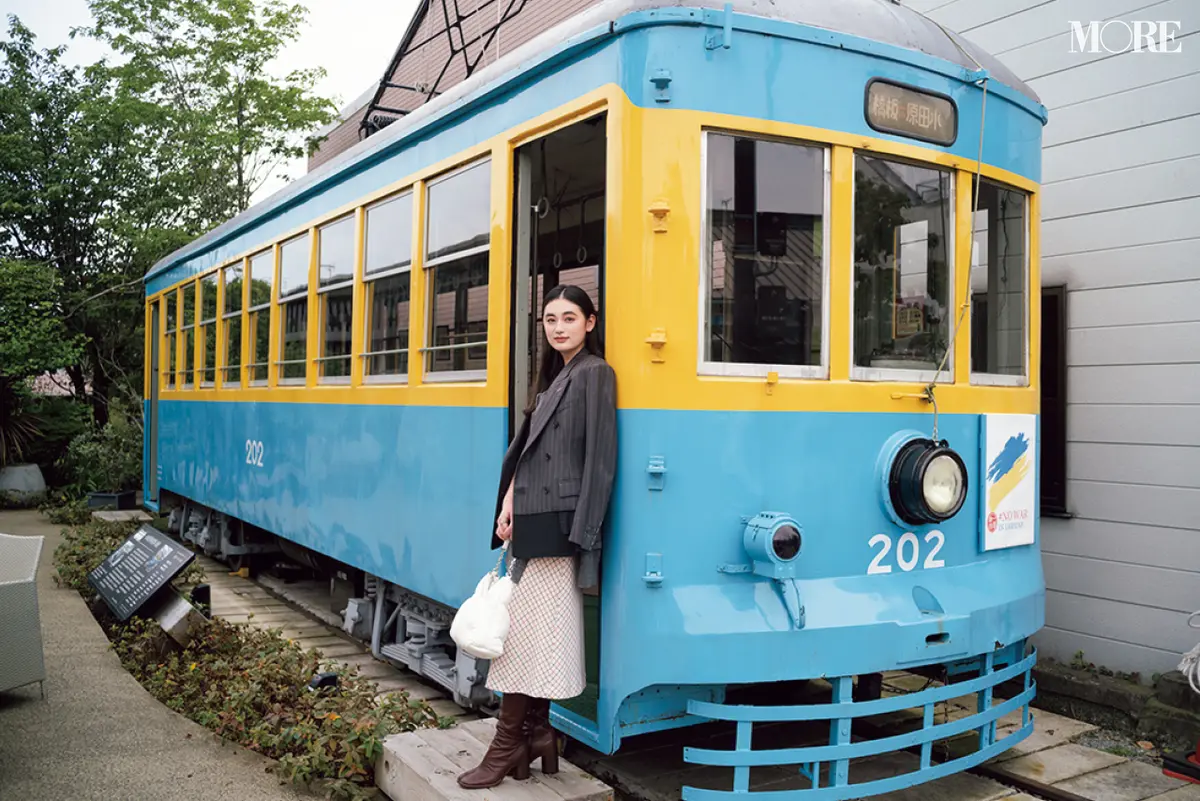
top-left (422, 159), bottom-right (496, 384)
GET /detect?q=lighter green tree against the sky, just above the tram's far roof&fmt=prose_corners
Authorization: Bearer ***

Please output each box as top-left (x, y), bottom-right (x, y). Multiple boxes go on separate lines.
top-left (85, 0), bottom-right (337, 216)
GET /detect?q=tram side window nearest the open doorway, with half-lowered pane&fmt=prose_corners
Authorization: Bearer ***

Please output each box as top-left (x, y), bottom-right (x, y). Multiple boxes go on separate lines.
top-left (425, 159), bottom-right (491, 378)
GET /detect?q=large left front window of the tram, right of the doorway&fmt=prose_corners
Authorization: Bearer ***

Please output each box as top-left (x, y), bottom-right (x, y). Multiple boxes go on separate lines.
top-left (704, 133), bottom-right (827, 377)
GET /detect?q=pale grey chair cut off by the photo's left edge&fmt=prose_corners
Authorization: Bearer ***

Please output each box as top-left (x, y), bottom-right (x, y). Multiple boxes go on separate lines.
top-left (0, 534), bottom-right (46, 698)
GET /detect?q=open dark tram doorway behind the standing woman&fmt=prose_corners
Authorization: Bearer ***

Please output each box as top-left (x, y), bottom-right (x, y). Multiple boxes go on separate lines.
top-left (509, 114), bottom-right (607, 722)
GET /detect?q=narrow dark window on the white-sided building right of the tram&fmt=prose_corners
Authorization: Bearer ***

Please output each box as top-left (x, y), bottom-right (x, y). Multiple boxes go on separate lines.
top-left (1040, 287), bottom-right (1067, 514)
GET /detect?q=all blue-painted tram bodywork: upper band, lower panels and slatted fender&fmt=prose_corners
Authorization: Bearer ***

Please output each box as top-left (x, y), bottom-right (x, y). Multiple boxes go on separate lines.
top-left (146, 10), bottom-right (1044, 799)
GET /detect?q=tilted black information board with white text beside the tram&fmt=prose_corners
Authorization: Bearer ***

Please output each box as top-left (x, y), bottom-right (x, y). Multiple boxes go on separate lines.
top-left (88, 525), bottom-right (196, 620)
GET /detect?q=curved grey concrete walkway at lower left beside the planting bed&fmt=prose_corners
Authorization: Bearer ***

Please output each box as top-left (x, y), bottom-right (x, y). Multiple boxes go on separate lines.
top-left (0, 512), bottom-right (319, 801)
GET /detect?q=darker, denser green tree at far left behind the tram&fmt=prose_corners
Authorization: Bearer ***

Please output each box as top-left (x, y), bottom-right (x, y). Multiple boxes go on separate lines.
top-left (0, 17), bottom-right (205, 426)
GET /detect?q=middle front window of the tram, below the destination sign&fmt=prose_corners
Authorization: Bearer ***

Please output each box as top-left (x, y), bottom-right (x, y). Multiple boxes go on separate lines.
top-left (853, 153), bottom-right (954, 380)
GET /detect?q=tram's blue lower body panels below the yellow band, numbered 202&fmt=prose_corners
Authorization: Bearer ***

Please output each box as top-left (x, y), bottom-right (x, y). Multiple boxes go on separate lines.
top-left (158, 401), bottom-right (1044, 751)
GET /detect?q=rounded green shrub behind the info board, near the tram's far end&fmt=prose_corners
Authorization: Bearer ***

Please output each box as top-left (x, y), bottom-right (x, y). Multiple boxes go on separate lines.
top-left (64, 415), bottom-right (142, 496)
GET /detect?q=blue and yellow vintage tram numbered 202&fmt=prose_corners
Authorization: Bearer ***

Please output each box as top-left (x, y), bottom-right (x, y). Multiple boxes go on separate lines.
top-left (138, 0), bottom-right (1046, 799)
